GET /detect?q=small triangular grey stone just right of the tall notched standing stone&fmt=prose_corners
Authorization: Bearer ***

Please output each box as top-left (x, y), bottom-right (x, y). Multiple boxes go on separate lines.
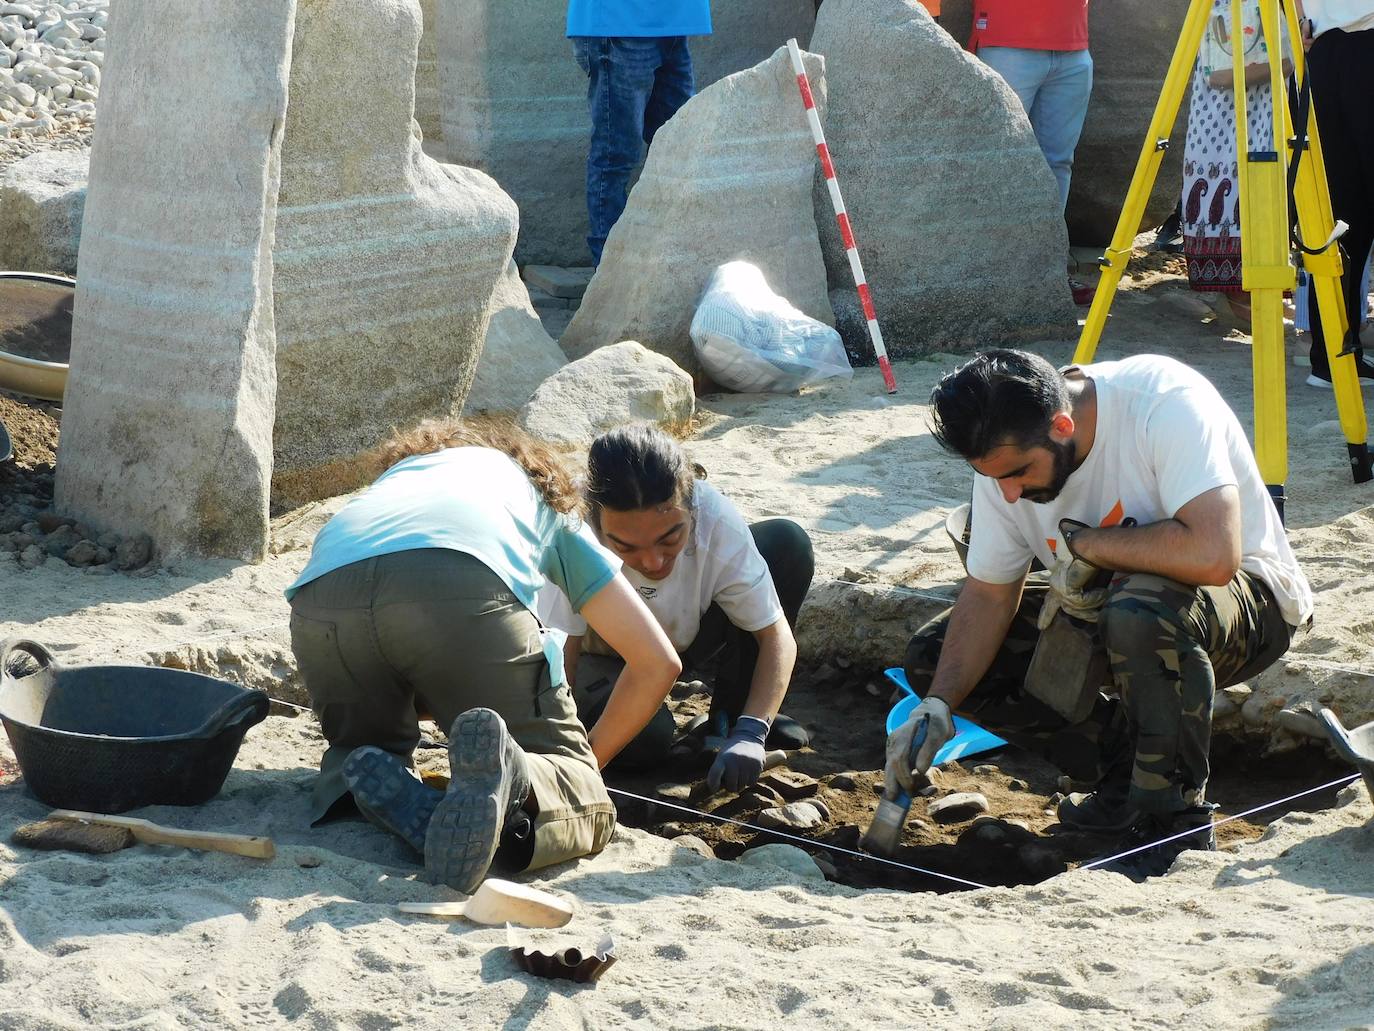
top-left (463, 261), bottom-right (567, 415)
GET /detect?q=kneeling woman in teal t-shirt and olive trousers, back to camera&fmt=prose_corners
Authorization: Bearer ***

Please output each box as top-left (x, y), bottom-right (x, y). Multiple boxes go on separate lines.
top-left (286, 422), bottom-right (682, 892)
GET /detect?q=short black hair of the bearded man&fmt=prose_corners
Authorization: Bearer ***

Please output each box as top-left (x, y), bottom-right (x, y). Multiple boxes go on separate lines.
top-left (930, 348), bottom-right (1069, 462)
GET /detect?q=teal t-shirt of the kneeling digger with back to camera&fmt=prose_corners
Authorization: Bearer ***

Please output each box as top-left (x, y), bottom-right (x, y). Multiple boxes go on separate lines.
top-left (286, 448), bottom-right (620, 685)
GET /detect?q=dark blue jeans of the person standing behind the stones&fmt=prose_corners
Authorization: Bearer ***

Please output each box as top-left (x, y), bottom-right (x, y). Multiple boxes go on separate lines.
top-left (573, 36), bottom-right (695, 265)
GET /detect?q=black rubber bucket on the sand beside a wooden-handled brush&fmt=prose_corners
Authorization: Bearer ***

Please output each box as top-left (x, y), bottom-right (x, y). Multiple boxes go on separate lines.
top-left (0, 639), bottom-right (269, 812)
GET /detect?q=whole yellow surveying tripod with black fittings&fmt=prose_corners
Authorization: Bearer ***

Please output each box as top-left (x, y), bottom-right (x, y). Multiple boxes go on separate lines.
top-left (1073, 0), bottom-right (1374, 516)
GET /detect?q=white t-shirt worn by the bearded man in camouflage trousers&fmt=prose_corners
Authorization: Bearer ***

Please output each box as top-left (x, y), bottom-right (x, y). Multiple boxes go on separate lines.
top-left (969, 355), bottom-right (1312, 627)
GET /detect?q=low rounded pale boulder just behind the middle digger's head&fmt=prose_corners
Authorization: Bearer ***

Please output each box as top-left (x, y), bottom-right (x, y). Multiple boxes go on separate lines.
top-left (519, 341), bottom-right (697, 447)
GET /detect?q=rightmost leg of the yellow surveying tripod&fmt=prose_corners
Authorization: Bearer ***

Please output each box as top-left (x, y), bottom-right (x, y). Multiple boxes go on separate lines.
top-left (1287, 4), bottom-right (1374, 484)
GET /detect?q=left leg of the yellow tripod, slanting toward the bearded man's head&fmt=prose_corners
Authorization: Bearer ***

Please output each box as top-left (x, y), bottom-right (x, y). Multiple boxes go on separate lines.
top-left (1073, 0), bottom-right (1212, 364)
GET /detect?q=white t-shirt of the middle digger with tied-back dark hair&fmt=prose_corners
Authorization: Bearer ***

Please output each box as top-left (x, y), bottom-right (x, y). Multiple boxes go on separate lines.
top-left (536, 480), bottom-right (783, 652)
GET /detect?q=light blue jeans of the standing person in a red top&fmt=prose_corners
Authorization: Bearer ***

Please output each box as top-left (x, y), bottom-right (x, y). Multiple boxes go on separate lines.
top-left (978, 47), bottom-right (1092, 206)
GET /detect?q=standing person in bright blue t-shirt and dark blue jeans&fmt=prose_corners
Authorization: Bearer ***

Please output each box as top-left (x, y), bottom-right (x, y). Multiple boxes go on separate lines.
top-left (567, 0), bottom-right (710, 265)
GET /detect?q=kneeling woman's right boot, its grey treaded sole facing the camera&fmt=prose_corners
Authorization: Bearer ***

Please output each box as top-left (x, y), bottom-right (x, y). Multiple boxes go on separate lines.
top-left (425, 709), bottom-right (529, 895)
